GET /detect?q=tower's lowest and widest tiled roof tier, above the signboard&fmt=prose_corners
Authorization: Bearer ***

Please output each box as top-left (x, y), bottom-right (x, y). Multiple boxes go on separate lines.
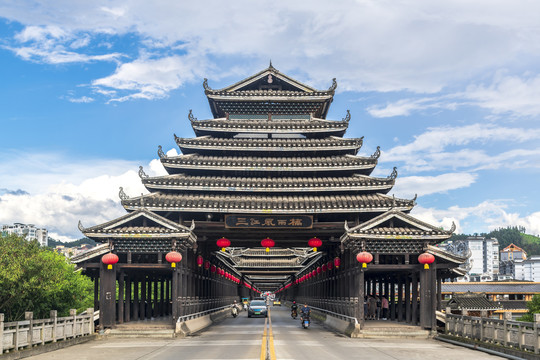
top-left (122, 193), bottom-right (414, 214)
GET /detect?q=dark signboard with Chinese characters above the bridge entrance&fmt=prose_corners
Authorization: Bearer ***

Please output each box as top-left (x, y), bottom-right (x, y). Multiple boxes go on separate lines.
top-left (225, 215), bottom-right (313, 229)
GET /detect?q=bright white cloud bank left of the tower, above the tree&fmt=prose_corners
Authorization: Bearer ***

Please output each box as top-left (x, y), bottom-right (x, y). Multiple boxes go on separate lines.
top-left (0, 153), bottom-right (168, 240)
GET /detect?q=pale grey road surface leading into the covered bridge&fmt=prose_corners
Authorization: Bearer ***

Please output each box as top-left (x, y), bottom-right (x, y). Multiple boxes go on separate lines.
top-left (25, 307), bottom-right (504, 360)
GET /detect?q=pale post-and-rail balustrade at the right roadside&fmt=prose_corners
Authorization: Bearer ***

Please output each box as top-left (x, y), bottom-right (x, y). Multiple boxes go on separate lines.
top-left (445, 313), bottom-right (540, 354)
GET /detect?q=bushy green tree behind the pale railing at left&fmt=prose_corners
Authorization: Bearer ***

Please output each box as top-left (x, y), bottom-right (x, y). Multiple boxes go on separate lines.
top-left (0, 235), bottom-right (93, 321)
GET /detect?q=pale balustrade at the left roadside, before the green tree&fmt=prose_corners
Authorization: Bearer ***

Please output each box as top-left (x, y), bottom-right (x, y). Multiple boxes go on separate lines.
top-left (0, 308), bottom-right (94, 354)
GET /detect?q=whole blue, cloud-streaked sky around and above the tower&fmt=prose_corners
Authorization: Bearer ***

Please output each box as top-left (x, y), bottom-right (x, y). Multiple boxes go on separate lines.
top-left (0, 0), bottom-right (540, 240)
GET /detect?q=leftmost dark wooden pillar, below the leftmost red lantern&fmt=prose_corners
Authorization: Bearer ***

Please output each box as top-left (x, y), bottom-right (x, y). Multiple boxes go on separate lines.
top-left (99, 262), bottom-right (116, 329)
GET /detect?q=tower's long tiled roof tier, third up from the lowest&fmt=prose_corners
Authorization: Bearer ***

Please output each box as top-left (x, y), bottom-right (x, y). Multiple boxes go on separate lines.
top-left (161, 154), bottom-right (377, 174)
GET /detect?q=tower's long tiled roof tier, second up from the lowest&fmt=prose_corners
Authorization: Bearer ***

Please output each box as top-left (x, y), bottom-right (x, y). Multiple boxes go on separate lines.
top-left (142, 174), bottom-right (395, 194)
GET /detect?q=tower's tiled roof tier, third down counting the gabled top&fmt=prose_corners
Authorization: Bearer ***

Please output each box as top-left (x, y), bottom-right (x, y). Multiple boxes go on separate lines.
top-left (175, 135), bottom-right (362, 155)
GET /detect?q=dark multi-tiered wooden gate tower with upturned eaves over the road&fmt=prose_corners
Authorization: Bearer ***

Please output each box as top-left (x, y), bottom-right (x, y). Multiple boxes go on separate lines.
top-left (77, 64), bottom-right (462, 327)
